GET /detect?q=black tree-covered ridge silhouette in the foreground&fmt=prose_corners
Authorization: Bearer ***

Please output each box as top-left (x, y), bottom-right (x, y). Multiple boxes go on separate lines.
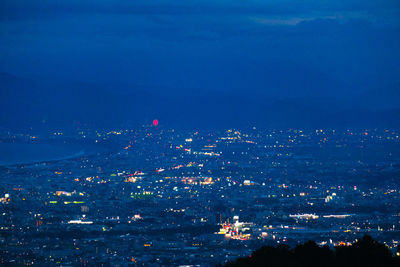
top-left (220, 235), bottom-right (400, 267)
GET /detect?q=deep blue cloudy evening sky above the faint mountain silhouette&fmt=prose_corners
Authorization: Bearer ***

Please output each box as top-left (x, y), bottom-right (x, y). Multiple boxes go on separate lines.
top-left (0, 0), bottom-right (400, 129)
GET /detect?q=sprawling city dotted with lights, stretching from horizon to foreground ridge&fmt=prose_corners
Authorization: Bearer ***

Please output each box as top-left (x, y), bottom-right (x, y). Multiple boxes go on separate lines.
top-left (0, 125), bottom-right (400, 266)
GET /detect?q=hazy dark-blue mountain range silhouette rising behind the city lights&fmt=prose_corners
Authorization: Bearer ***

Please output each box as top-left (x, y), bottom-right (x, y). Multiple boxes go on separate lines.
top-left (0, 73), bottom-right (400, 131)
